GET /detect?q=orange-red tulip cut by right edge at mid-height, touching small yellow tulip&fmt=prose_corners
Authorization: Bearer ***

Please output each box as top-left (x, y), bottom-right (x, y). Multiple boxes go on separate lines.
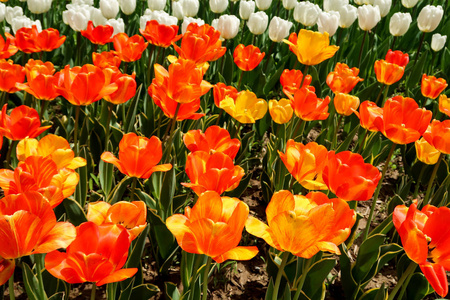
top-left (423, 120), bottom-right (450, 154)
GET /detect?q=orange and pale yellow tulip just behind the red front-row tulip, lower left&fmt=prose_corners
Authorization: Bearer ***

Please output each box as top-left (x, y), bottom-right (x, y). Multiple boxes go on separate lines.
top-left (87, 201), bottom-right (147, 240)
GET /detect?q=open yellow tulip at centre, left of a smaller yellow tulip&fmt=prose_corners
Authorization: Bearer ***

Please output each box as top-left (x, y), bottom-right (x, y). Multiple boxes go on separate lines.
top-left (220, 91), bottom-right (267, 124)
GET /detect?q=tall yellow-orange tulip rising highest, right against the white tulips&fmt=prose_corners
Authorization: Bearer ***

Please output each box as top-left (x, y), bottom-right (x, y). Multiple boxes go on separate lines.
top-left (284, 29), bottom-right (339, 66)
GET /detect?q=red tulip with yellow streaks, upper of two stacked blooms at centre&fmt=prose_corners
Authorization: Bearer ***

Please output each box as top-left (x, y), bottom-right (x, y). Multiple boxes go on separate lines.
top-left (183, 126), bottom-right (241, 159)
